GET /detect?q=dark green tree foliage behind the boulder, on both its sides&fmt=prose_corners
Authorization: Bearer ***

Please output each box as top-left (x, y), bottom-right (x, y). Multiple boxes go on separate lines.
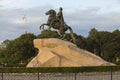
top-left (0, 28), bottom-right (120, 64)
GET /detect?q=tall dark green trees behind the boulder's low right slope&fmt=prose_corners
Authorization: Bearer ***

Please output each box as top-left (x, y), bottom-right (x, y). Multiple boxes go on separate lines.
top-left (88, 29), bottom-right (120, 64)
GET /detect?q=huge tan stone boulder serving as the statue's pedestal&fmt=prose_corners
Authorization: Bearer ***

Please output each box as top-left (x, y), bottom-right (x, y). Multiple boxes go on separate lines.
top-left (27, 38), bottom-right (113, 67)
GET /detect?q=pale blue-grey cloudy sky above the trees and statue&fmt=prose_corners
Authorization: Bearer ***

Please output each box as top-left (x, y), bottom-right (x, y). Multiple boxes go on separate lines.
top-left (0, 0), bottom-right (120, 42)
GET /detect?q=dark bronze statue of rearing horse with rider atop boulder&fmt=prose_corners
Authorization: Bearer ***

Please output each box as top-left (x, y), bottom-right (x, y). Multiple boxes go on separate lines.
top-left (40, 7), bottom-right (76, 43)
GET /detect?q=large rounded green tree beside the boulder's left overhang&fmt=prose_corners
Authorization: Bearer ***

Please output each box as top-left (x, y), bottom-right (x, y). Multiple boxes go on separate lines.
top-left (5, 33), bottom-right (36, 64)
